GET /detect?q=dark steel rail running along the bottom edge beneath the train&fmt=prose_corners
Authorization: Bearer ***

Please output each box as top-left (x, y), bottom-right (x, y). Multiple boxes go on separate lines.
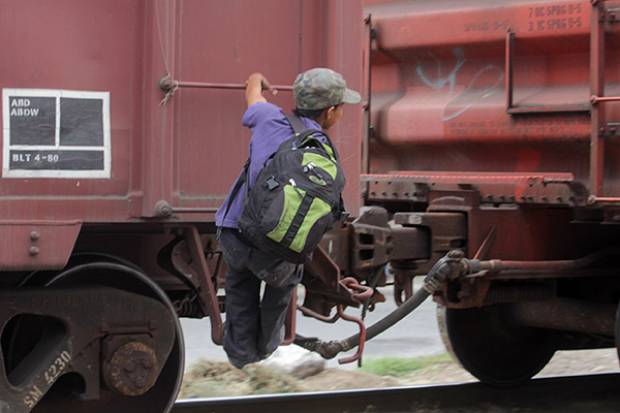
top-left (172, 374), bottom-right (620, 413)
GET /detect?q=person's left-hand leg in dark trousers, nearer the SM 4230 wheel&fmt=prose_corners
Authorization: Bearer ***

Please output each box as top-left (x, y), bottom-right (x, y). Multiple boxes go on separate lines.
top-left (220, 230), bottom-right (260, 368)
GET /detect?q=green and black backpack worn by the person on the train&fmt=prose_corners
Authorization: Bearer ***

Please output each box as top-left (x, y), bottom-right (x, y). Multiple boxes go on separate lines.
top-left (233, 116), bottom-right (345, 263)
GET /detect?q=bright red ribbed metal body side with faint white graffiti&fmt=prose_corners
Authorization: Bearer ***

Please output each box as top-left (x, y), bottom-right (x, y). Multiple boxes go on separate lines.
top-left (364, 0), bottom-right (620, 198)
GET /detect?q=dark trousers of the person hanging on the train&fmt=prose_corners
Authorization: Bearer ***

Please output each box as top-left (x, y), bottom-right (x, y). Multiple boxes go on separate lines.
top-left (220, 228), bottom-right (302, 368)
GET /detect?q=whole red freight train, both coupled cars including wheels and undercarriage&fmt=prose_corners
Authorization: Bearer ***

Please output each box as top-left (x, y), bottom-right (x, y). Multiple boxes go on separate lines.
top-left (0, 0), bottom-right (620, 413)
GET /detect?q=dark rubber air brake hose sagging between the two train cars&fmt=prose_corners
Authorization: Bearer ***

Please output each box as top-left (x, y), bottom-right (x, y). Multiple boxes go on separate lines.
top-left (295, 250), bottom-right (464, 359)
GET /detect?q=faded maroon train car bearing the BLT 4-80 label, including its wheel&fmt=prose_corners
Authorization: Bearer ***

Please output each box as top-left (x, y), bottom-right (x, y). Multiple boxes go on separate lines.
top-left (0, 0), bottom-right (364, 412)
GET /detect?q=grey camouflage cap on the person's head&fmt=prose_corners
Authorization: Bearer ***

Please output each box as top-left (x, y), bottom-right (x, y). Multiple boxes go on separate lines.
top-left (293, 67), bottom-right (362, 110)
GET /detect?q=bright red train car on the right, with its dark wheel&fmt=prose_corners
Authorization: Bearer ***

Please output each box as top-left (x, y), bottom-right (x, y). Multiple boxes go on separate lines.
top-left (362, 0), bottom-right (620, 384)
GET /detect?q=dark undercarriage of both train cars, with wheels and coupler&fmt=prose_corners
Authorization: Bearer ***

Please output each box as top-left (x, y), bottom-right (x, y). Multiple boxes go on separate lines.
top-left (0, 185), bottom-right (620, 413)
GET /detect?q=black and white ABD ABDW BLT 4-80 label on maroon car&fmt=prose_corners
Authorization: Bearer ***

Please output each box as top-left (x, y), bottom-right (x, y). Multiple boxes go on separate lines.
top-left (2, 89), bottom-right (111, 178)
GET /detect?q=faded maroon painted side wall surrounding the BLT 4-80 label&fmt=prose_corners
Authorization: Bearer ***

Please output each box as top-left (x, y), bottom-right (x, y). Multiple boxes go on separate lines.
top-left (0, 0), bottom-right (363, 222)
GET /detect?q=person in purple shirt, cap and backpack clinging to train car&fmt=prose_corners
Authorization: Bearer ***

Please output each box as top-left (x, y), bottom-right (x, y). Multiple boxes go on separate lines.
top-left (216, 68), bottom-right (361, 368)
